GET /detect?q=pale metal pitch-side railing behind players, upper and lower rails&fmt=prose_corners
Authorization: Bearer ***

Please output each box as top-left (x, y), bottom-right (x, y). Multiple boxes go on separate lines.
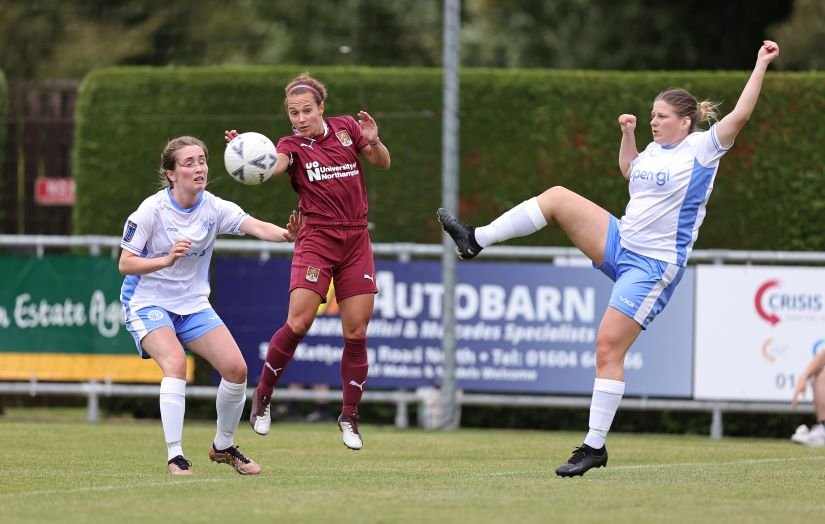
top-left (0, 235), bottom-right (825, 438)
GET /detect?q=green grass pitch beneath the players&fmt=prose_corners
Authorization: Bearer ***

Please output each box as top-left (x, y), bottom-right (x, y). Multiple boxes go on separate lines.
top-left (0, 410), bottom-right (825, 524)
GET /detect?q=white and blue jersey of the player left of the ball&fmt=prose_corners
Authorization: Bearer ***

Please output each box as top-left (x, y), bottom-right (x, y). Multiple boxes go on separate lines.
top-left (120, 189), bottom-right (248, 320)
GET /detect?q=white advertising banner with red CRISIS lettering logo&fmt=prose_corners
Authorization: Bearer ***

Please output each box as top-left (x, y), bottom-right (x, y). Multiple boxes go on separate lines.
top-left (693, 266), bottom-right (825, 401)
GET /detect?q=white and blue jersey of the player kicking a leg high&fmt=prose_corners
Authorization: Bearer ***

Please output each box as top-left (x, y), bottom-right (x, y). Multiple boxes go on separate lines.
top-left (619, 125), bottom-right (730, 266)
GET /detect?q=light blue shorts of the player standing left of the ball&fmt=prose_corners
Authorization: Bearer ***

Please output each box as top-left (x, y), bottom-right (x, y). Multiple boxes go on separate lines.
top-left (126, 306), bottom-right (224, 358)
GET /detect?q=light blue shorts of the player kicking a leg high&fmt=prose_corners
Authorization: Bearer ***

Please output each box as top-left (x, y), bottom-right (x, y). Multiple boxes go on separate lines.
top-left (593, 215), bottom-right (685, 329)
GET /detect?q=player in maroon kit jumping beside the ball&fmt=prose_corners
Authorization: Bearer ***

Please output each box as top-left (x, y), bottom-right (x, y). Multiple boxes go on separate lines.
top-left (225, 73), bottom-right (390, 450)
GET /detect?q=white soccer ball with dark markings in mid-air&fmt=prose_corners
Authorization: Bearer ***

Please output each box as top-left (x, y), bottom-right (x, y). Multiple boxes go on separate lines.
top-left (223, 131), bottom-right (278, 186)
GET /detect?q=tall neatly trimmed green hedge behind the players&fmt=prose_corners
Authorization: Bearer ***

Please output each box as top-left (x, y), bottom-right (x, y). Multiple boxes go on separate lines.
top-left (73, 66), bottom-right (825, 251)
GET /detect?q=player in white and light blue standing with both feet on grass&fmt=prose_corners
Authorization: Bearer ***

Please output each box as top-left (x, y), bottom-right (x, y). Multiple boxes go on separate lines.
top-left (118, 136), bottom-right (300, 475)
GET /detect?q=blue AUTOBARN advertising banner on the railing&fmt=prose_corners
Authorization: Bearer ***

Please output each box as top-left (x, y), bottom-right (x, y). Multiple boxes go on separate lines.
top-left (212, 257), bottom-right (694, 398)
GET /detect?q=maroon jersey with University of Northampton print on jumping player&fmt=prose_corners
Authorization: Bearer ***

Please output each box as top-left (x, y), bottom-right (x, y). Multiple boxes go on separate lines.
top-left (277, 116), bottom-right (368, 222)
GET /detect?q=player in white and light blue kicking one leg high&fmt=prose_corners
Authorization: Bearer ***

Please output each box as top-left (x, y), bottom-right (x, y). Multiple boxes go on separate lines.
top-left (438, 40), bottom-right (779, 477)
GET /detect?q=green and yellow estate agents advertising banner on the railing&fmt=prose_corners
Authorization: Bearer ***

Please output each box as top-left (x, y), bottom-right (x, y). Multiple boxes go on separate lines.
top-left (0, 255), bottom-right (181, 382)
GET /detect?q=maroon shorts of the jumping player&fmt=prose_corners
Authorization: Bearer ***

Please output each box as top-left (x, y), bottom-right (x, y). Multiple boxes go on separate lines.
top-left (289, 224), bottom-right (378, 302)
